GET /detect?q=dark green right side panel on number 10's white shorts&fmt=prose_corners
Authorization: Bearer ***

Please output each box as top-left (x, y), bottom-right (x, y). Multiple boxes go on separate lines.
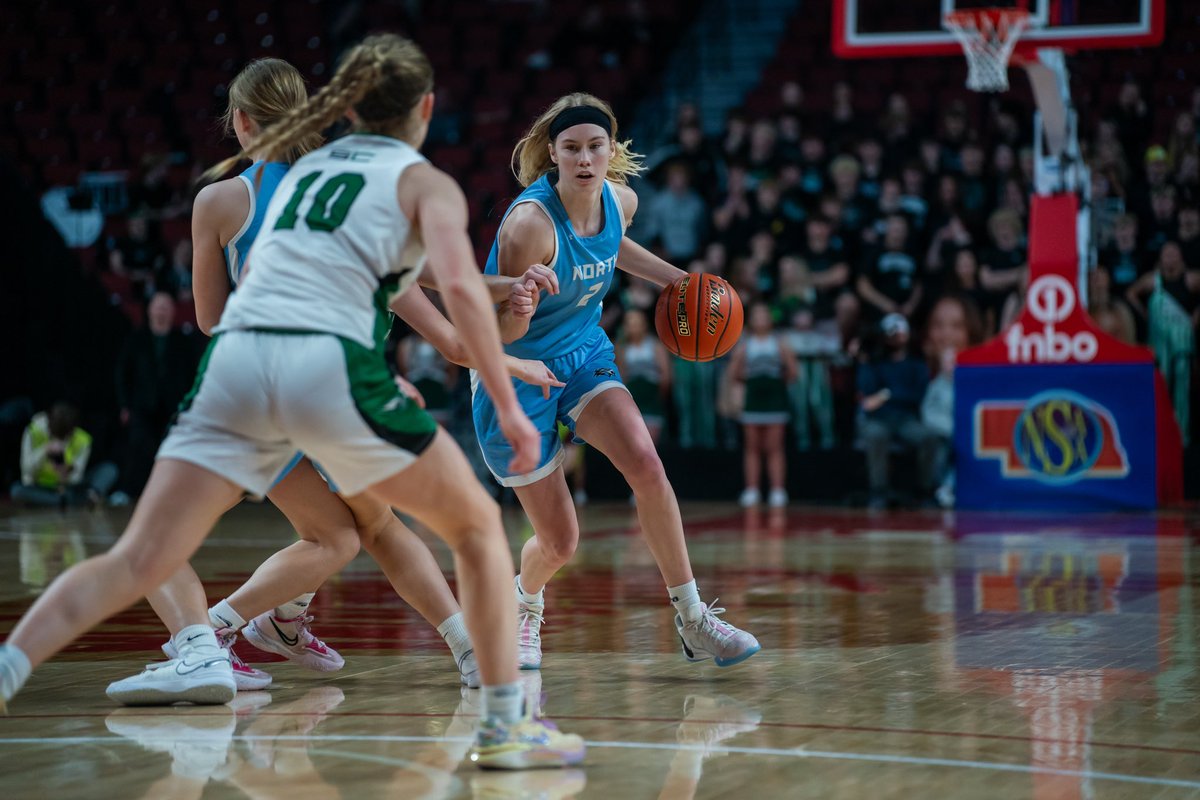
top-left (337, 336), bottom-right (438, 453)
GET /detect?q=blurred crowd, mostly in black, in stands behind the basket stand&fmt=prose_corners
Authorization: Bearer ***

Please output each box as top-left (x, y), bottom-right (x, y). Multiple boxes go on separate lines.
top-left (620, 80), bottom-right (1200, 505)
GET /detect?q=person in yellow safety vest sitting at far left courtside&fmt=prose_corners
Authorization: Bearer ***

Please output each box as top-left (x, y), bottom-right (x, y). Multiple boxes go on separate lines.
top-left (11, 403), bottom-right (116, 506)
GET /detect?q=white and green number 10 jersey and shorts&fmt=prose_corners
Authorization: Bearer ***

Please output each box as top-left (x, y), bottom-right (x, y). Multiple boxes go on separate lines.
top-left (158, 134), bottom-right (437, 494)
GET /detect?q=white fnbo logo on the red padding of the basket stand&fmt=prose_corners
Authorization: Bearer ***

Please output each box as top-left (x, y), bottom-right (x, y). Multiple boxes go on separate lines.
top-left (1004, 275), bottom-right (1100, 363)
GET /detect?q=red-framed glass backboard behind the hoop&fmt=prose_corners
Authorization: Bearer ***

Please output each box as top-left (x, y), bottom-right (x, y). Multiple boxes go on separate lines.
top-left (833, 0), bottom-right (1166, 59)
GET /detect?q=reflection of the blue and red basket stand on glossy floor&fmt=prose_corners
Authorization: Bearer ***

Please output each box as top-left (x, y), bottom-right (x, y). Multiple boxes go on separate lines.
top-left (954, 518), bottom-right (1195, 800)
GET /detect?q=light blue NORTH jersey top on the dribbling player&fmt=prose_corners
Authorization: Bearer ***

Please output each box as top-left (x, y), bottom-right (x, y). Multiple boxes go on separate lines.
top-left (484, 173), bottom-right (625, 361)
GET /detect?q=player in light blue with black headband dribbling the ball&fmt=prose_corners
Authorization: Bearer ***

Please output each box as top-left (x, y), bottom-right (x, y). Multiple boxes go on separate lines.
top-left (473, 94), bottom-right (760, 669)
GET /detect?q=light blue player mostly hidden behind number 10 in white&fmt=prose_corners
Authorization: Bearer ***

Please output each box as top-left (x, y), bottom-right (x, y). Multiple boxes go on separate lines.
top-left (108, 59), bottom-right (566, 704)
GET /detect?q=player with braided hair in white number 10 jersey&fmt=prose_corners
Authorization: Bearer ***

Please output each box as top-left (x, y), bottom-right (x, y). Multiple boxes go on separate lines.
top-left (0, 35), bottom-right (583, 769)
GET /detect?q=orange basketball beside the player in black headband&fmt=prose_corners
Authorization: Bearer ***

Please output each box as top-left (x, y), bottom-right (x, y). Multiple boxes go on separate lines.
top-left (654, 272), bottom-right (742, 361)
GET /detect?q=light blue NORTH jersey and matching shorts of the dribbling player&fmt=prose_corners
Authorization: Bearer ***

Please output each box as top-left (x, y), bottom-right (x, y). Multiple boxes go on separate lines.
top-left (472, 176), bottom-right (625, 486)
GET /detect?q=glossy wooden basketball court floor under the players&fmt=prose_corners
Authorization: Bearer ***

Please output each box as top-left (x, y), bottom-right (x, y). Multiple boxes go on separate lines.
top-left (0, 505), bottom-right (1200, 800)
